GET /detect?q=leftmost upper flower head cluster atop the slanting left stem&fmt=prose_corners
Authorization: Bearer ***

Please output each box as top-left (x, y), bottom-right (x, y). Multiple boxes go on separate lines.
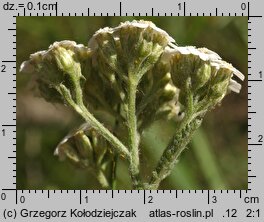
top-left (20, 41), bottom-right (84, 104)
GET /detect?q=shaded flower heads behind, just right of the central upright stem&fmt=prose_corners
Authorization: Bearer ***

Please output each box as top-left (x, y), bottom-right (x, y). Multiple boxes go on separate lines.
top-left (137, 57), bottom-right (178, 128)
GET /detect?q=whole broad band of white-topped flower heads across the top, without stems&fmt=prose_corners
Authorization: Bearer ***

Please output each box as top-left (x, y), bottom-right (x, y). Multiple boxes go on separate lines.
top-left (21, 20), bottom-right (244, 133)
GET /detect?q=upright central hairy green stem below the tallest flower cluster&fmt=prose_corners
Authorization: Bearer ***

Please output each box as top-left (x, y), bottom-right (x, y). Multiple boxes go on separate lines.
top-left (127, 80), bottom-right (141, 189)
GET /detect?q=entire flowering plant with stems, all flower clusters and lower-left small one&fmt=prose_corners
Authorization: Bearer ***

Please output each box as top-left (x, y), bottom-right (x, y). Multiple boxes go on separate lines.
top-left (20, 20), bottom-right (244, 189)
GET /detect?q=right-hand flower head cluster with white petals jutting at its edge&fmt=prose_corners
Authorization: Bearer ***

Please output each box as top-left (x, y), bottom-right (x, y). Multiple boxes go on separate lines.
top-left (162, 46), bottom-right (244, 110)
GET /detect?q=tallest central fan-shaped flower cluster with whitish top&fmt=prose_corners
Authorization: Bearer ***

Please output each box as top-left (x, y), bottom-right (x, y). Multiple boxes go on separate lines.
top-left (89, 21), bottom-right (174, 82)
